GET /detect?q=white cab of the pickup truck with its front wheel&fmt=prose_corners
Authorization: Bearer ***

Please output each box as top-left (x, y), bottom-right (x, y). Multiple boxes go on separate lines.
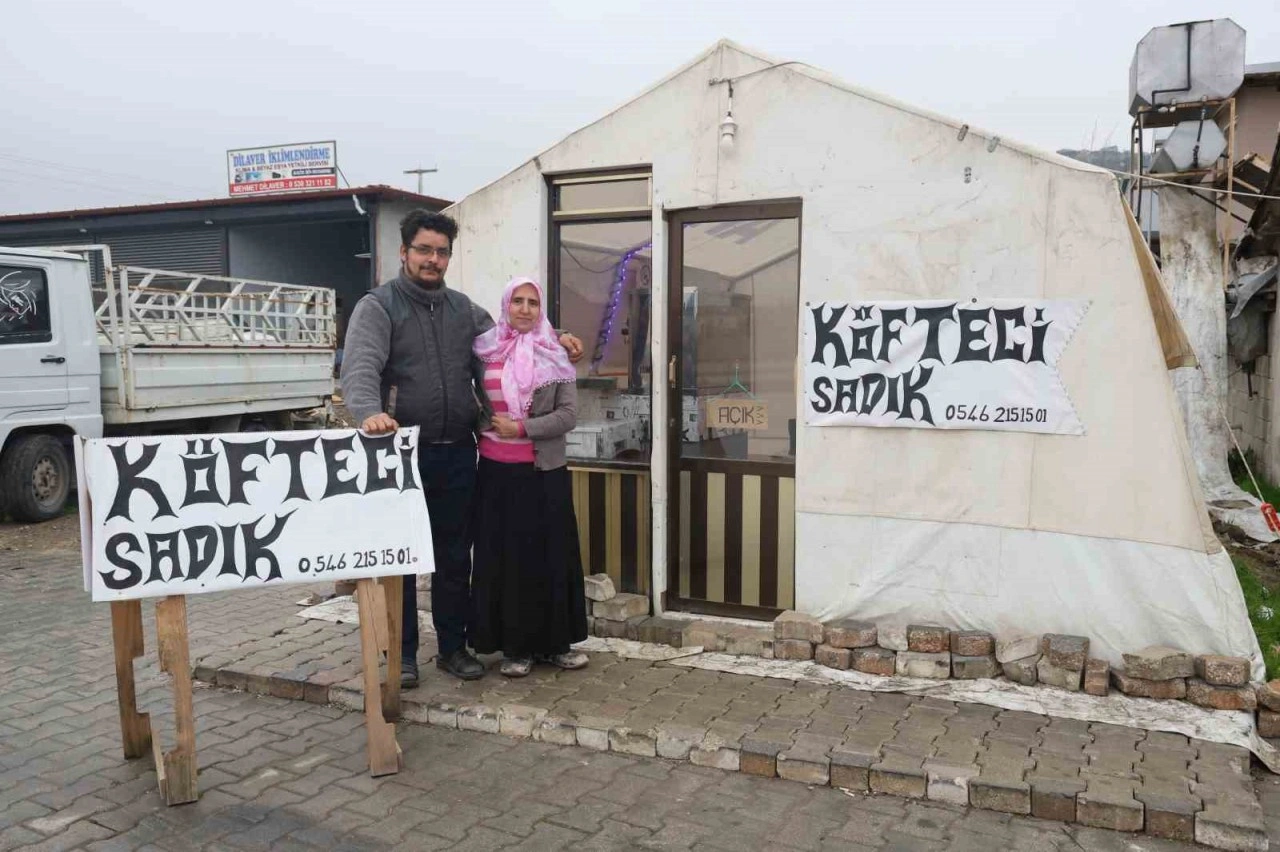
top-left (0, 248), bottom-right (102, 521)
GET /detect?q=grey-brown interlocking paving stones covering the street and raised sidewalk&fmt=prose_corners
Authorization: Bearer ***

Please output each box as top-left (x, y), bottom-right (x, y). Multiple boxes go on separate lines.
top-left (0, 541), bottom-right (1280, 852)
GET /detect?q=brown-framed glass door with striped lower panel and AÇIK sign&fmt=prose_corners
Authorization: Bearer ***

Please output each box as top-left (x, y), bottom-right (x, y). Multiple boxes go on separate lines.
top-left (666, 203), bottom-right (800, 618)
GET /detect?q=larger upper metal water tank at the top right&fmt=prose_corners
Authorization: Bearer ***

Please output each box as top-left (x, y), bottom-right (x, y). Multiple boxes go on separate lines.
top-left (1129, 18), bottom-right (1244, 115)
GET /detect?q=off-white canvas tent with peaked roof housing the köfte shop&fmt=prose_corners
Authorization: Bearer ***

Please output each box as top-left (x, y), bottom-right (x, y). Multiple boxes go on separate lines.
top-left (451, 42), bottom-right (1262, 675)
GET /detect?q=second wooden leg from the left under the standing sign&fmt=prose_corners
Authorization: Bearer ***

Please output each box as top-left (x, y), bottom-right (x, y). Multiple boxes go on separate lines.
top-left (155, 595), bottom-right (200, 805)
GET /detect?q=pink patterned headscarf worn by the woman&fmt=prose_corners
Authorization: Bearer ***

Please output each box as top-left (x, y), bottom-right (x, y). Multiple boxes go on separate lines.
top-left (472, 278), bottom-right (577, 420)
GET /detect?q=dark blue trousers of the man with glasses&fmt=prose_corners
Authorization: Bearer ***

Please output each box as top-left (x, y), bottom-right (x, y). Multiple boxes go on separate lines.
top-left (401, 441), bottom-right (476, 663)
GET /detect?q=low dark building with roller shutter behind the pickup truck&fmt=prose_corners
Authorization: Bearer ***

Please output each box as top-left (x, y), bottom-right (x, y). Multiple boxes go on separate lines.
top-left (0, 185), bottom-right (449, 327)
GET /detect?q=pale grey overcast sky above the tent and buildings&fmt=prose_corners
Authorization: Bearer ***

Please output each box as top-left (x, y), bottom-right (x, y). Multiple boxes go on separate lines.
top-left (0, 0), bottom-right (1280, 212)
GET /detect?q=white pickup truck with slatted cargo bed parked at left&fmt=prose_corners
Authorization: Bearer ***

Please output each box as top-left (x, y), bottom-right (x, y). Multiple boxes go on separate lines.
top-left (0, 246), bottom-right (337, 521)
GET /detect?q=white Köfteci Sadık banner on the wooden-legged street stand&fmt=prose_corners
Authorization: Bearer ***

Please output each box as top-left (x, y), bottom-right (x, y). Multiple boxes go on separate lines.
top-left (77, 427), bottom-right (434, 600)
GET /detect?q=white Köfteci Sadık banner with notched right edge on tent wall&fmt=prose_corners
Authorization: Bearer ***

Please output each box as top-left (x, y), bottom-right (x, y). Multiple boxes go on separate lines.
top-left (803, 299), bottom-right (1089, 435)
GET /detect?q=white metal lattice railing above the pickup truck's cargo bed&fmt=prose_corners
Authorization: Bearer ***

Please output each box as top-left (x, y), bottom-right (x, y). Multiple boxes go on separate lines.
top-left (51, 246), bottom-right (337, 349)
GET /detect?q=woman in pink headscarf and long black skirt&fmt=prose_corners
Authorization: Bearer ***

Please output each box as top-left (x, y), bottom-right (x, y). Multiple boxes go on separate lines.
top-left (470, 278), bottom-right (588, 678)
